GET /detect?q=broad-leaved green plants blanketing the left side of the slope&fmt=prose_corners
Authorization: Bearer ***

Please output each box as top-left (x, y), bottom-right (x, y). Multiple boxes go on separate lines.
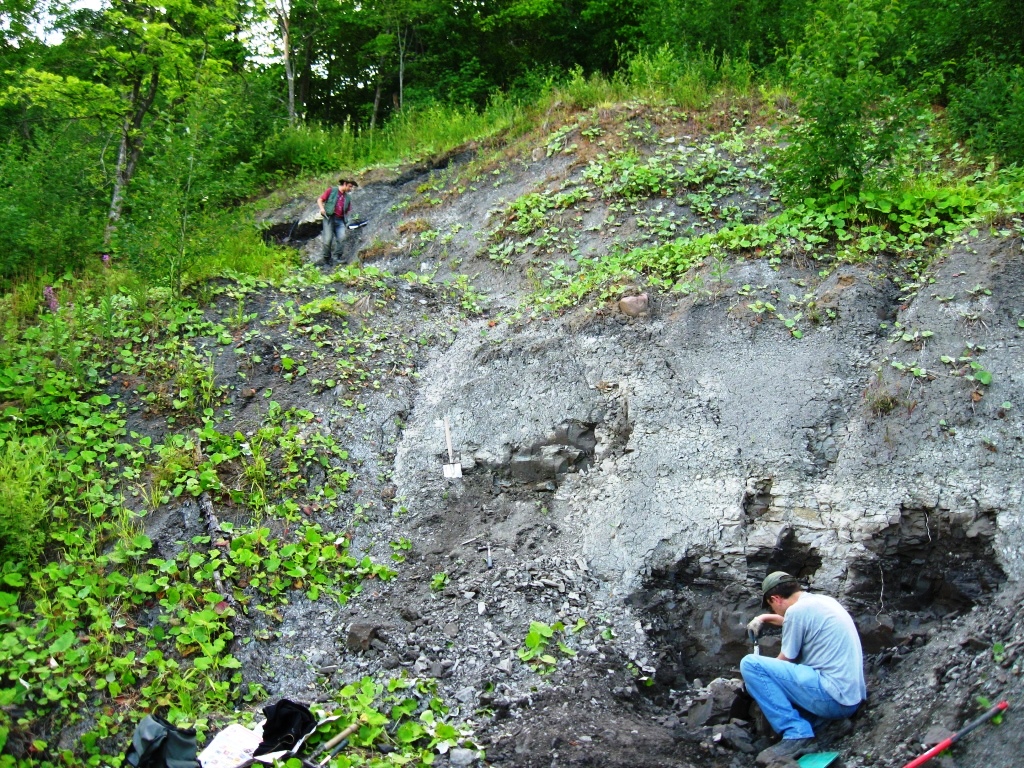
top-left (0, 267), bottom-right (464, 765)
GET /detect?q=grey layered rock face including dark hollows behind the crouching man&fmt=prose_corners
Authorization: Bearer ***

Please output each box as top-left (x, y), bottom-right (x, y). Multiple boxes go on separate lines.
top-left (396, 234), bottom-right (1024, 679)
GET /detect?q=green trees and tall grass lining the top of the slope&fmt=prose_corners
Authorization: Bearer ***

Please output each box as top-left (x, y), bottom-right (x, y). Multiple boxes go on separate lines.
top-left (0, 0), bottom-right (1024, 290)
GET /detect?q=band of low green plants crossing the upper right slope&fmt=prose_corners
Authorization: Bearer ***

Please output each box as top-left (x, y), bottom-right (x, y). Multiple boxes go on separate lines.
top-left (503, 121), bottom-right (1024, 313)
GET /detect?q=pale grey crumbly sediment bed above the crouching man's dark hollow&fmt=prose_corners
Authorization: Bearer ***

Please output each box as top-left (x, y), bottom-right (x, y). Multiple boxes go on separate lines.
top-left (396, 239), bottom-right (1024, 606)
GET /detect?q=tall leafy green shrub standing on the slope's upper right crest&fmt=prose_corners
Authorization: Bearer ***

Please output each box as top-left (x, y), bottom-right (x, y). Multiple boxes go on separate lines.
top-left (780, 0), bottom-right (916, 200)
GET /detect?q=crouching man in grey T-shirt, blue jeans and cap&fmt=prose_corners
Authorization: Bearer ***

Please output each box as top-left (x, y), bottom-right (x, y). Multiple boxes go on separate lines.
top-left (739, 570), bottom-right (867, 765)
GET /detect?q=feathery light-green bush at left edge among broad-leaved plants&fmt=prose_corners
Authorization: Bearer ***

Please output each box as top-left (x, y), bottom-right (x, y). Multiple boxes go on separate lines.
top-left (0, 437), bottom-right (52, 563)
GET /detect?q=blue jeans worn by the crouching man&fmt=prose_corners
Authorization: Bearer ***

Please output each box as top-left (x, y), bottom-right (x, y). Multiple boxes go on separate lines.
top-left (739, 654), bottom-right (860, 738)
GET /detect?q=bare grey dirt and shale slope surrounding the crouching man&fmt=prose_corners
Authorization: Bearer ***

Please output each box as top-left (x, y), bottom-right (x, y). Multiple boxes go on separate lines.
top-left (235, 108), bottom-right (1024, 768)
